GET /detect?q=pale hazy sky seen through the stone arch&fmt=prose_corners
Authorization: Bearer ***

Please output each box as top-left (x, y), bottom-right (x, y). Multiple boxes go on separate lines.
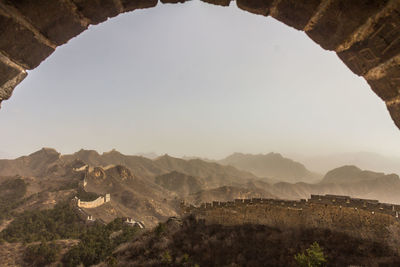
top-left (0, 1), bottom-right (400, 158)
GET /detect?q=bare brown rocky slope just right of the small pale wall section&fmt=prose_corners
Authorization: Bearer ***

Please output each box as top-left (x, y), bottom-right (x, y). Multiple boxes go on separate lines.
top-left (85, 165), bottom-right (179, 227)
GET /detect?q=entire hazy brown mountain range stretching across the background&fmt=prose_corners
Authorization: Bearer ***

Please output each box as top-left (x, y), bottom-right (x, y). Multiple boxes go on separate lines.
top-left (0, 148), bottom-right (400, 226)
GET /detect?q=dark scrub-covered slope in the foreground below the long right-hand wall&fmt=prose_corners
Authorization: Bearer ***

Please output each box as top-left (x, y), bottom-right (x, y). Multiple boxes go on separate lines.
top-left (100, 218), bottom-right (400, 267)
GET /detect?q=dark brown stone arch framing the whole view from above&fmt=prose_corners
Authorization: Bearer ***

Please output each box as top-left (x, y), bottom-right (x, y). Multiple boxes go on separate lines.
top-left (0, 0), bottom-right (400, 128)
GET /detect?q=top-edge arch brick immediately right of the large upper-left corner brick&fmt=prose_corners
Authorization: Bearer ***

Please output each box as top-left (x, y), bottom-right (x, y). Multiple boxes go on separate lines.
top-left (73, 0), bottom-right (120, 24)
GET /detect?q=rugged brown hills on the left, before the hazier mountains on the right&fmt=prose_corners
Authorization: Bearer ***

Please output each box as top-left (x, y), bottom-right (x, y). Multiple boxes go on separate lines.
top-left (0, 148), bottom-right (257, 227)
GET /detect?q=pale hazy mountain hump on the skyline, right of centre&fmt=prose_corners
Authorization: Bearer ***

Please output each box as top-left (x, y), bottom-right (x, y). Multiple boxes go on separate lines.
top-left (219, 153), bottom-right (320, 183)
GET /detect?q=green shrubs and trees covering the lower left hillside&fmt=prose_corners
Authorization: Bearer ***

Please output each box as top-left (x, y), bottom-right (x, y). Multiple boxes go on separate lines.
top-left (0, 203), bottom-right (140, 267)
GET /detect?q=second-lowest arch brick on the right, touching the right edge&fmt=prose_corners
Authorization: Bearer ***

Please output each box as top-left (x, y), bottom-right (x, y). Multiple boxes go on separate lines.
top-left (367, 65), bottom-right (400, 101)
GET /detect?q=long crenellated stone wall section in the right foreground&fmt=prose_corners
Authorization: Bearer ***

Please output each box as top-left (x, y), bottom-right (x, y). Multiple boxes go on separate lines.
top-left (181, 195), bottom-right (400, 249)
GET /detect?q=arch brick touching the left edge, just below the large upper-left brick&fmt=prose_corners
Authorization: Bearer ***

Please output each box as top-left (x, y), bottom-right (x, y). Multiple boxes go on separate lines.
top-left (0, 14), bottom-right (54, 69)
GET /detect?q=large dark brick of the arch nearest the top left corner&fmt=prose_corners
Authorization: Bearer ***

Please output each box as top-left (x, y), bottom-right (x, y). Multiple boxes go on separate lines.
top-left (8, 0), bottom-right (87, 45)
